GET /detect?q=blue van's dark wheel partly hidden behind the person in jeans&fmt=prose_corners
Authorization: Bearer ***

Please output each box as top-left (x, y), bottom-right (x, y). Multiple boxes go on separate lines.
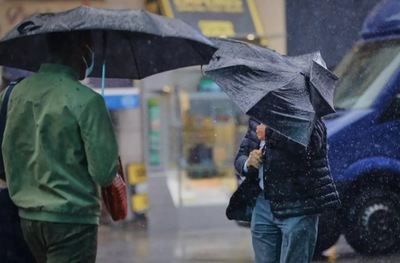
top-left (314, 212), bottom-right (341, 258)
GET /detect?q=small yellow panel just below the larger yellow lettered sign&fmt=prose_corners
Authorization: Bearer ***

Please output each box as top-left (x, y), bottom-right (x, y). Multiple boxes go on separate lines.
top-left (199, 20), bottom-right (235, 37)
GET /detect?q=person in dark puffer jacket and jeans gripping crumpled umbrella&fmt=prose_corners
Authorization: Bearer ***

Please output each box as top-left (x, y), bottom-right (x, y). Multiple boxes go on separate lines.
top-left (231, 118), bottom-right (341, 263)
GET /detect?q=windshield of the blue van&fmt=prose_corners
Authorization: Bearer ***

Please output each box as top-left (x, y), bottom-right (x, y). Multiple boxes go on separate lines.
top-left (335, 40), bottom-right (400, 109)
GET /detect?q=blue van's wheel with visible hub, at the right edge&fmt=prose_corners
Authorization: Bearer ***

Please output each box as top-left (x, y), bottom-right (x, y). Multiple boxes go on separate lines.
top-left (345, 188), bottom-right (400, 255)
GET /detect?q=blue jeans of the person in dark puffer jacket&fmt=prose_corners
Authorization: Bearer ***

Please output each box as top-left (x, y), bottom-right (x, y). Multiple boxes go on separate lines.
top-left (251, 193), bottom-right (318, 263)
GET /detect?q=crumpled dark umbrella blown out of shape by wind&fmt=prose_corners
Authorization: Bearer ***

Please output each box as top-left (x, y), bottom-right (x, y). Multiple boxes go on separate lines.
top-left (205, 39), bottom-right (337, 146)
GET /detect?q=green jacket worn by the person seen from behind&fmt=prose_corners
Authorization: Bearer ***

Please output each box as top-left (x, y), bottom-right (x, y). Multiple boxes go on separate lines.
top-left (1, 64), bottom-right (118, 224)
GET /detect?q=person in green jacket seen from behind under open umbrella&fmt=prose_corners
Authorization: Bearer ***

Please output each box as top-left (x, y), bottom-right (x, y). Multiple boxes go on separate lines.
top-left (2, 32), bottom-right (118, 263)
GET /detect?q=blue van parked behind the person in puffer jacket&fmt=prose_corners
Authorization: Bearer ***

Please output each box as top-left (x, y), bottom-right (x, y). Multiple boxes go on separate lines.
top-left (316, 0), bottom-right (400, 254)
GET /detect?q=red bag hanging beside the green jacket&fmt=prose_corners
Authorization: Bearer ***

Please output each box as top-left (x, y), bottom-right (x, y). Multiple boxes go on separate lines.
top-left (101, 158), bottom-right (128, 221)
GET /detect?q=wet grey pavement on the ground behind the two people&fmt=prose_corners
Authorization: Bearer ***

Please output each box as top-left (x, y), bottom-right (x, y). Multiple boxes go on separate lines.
top-left (97, 224), bottom-right (400, 263)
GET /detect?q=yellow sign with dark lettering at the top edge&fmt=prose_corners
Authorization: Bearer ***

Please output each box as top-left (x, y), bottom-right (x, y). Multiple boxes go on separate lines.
top-left (174, 0), bottom-right (243, 13)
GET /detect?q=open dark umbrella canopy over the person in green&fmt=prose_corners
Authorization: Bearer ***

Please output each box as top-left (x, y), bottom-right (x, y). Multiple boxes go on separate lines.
top-left (0, 7), bottom-right (216, 79)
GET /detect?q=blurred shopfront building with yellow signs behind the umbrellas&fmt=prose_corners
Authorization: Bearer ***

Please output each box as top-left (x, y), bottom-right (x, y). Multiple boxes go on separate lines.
top-left (0, 0), bottom-right (378, 225)
